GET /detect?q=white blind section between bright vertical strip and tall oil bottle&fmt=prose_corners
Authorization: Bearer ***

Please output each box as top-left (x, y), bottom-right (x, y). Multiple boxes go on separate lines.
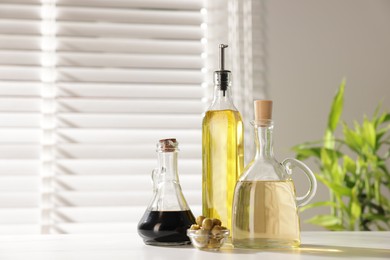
top-left (56, 1), bottom-right (203, 233)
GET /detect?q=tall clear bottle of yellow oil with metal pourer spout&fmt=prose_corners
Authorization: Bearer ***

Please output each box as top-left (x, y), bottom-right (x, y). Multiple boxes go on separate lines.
top-left (202, 44), bottom-right (244, 229)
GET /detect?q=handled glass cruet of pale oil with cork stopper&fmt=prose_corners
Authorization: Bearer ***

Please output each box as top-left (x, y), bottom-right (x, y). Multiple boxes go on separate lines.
top-left (232, 100), bottom-right (317, 248)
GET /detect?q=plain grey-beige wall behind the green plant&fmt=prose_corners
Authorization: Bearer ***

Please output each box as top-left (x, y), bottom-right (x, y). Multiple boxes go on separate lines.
top-left (266, 0), bottom-right (390, 230)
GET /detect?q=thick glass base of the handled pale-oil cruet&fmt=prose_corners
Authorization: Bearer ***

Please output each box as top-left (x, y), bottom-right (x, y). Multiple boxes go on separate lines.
top-left (233, 238), bottom-right (301, 249)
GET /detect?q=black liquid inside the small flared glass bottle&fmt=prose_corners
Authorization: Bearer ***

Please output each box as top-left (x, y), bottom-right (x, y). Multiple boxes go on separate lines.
top-left (138, 210), bottom-right (195, 245)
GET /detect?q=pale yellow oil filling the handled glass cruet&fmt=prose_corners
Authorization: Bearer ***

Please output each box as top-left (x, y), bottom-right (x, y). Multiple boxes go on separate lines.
top-left (233, 180), bottom-right (300, 247)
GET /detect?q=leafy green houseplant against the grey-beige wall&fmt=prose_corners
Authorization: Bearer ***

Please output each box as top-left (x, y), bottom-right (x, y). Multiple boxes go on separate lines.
top-left (293, 81), bottom-right (390, 230)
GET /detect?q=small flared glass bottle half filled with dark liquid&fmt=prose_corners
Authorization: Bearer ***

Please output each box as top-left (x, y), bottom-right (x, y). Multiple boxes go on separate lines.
top-left (138, 138), bottom-right (195, 246)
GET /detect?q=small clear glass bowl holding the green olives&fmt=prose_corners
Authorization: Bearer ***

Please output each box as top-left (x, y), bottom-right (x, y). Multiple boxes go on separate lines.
top-left (187, 229), bottom-right (230, 250)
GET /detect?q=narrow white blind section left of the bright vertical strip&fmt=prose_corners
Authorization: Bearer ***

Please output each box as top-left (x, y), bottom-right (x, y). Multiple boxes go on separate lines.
top-left (0, 1), bottom-right (41, 234)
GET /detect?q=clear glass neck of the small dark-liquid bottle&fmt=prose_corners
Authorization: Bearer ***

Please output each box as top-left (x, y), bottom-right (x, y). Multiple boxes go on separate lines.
top-left (158, 151), bottom-right (179, 183)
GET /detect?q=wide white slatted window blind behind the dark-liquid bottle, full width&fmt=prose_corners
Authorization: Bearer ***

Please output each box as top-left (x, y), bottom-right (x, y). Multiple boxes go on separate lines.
top-left (0, 0), bottom-right (205, 234)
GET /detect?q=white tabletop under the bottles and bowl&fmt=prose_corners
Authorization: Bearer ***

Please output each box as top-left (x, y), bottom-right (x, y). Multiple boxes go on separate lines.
top-left (0, 232), bottom-right (390, 260)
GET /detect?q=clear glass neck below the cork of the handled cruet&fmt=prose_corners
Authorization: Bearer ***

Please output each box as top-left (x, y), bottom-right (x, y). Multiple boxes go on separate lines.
top-left (254, 123), bottom-right (274, 159)
